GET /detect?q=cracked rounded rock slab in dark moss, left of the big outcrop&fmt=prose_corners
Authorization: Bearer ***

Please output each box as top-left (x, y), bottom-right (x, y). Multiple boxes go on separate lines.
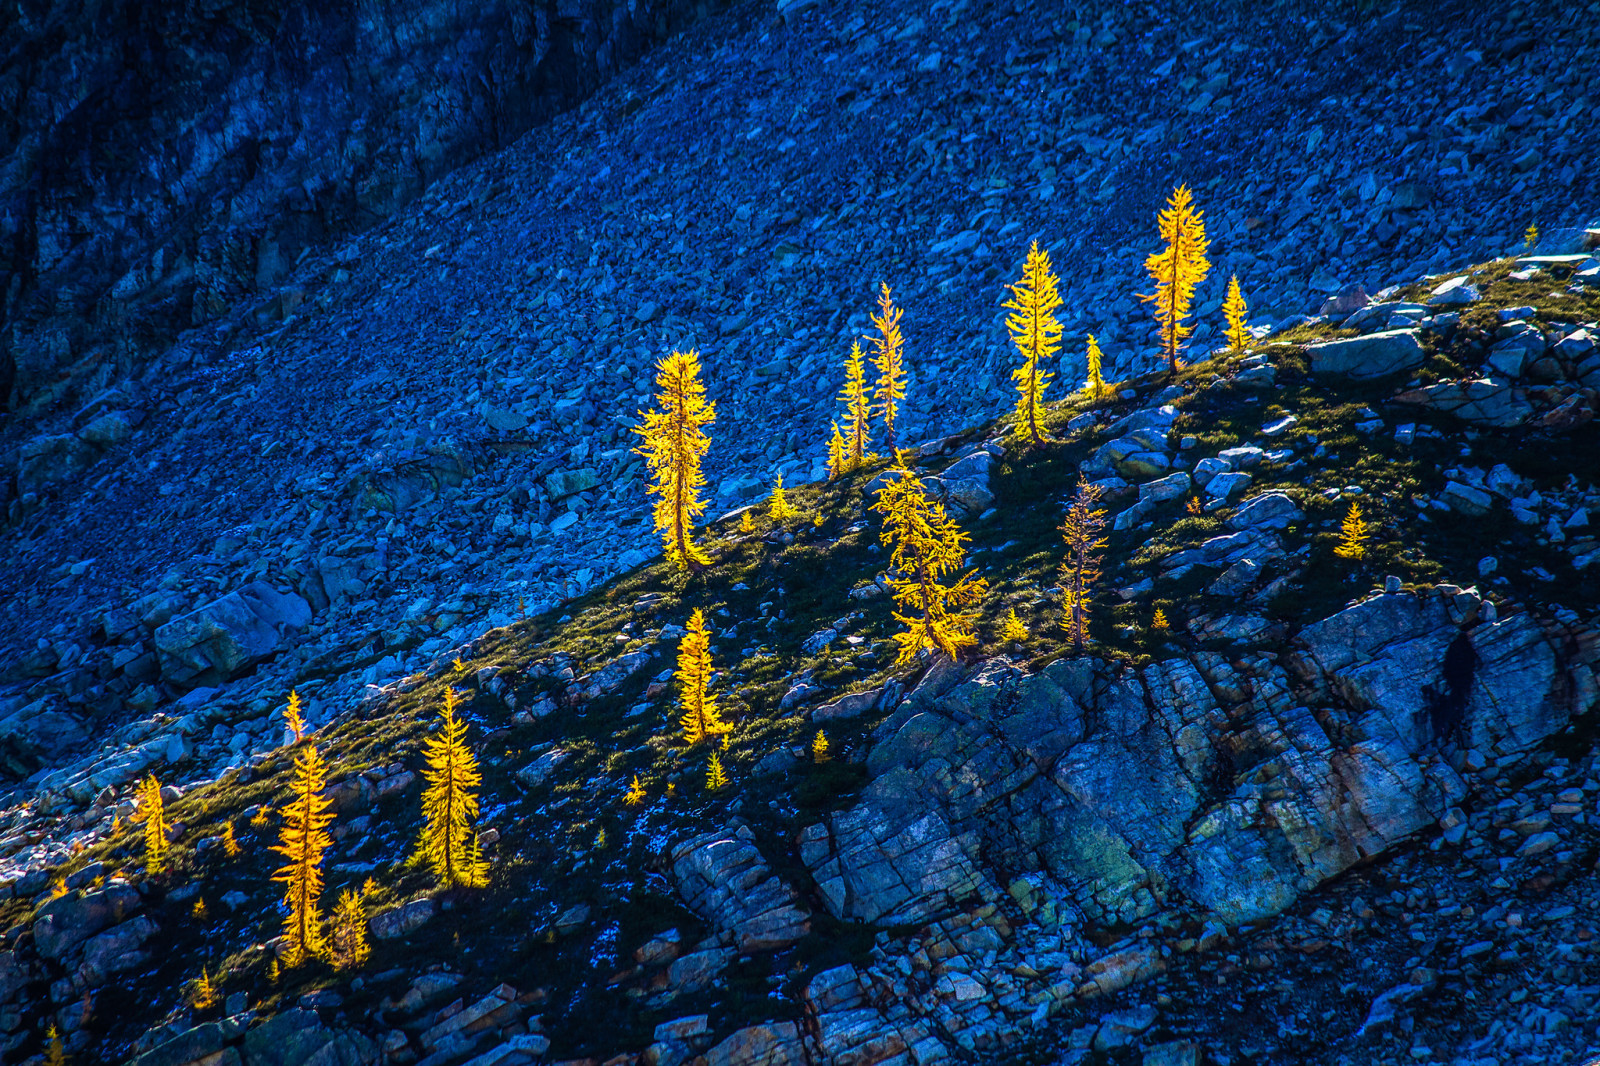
top-left (672, 832), bottom-right (811, 952)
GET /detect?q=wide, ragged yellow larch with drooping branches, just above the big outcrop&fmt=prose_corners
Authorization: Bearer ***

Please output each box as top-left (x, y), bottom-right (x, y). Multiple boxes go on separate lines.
top-left (872, 466), bottom-right (989, 666)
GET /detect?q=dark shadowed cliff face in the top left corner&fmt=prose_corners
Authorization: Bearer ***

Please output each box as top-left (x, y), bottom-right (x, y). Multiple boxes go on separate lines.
top-left (0, 0), bottom-right (717, 410)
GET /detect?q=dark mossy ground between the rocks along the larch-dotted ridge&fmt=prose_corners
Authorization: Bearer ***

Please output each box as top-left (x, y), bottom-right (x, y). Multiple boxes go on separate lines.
top-left (31, 261), bottom-right (1600, 1061)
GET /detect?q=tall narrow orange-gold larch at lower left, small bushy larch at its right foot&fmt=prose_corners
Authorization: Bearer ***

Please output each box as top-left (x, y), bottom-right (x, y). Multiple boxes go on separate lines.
top-left (272, 744), bottom-right (333, 967)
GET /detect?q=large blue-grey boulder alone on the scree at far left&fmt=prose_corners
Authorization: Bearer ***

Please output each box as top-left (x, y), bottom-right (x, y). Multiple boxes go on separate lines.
top-left (155, 581), bottom-right (310, 688)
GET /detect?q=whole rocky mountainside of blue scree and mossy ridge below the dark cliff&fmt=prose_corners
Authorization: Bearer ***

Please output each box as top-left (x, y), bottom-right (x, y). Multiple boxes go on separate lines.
top-left (0, 0), bottom-right (1600, 1066)
